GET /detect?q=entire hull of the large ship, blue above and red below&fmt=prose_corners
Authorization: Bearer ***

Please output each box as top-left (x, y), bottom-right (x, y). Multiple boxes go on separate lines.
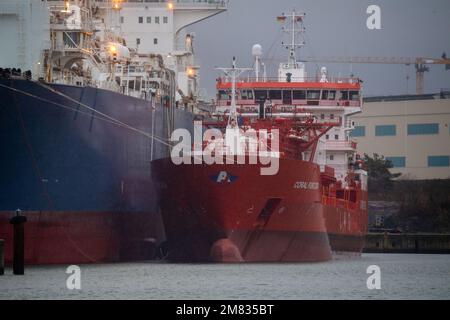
top-left (0, 79), bottom-right (192, 264)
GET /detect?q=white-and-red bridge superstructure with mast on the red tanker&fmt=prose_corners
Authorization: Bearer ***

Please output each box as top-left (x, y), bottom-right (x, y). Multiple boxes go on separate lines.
top-left (216, 12), bottom-right (366, 186)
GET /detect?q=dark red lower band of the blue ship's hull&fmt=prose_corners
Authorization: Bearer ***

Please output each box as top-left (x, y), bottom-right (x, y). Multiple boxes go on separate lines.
top-left (0, 212), bottom-right (162, 264)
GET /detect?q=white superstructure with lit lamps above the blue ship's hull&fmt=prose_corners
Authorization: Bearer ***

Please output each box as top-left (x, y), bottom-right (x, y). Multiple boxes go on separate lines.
top-left (0, 0), bottom-right (227, 106)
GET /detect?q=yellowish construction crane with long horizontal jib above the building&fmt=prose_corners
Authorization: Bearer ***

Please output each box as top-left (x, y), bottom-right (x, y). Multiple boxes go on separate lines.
top-left (305, 52), bottom-right (450, 94)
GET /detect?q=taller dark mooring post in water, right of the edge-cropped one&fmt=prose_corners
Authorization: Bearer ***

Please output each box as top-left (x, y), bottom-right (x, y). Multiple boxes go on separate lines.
top-left (9, 210), bottom-right (27, 275)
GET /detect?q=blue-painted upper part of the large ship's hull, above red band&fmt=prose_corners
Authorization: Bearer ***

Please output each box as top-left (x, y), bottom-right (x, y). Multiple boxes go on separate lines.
top-left (0, 79), bottom-right (193, 262)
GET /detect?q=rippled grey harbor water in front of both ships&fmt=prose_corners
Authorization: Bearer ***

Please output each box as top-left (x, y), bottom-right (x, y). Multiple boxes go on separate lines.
top-left (0, 254), bottom-right (450, 299)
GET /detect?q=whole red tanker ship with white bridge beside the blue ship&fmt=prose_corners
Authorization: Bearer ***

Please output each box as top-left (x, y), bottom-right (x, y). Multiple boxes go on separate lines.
top-left (152, 12), bottom-right (367, 262)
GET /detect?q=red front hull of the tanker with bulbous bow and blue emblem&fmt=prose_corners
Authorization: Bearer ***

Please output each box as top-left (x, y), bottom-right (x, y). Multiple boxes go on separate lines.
top-left (152, 159), bottom-right (332, 262)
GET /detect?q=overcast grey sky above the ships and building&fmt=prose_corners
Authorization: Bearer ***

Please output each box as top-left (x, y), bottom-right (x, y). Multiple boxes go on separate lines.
top-left (188, 0), bottom-right (450, 98)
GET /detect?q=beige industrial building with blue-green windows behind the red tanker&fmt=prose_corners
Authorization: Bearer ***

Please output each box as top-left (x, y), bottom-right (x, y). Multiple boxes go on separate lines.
top-left (351, 90), bottom-right (450, 179)
